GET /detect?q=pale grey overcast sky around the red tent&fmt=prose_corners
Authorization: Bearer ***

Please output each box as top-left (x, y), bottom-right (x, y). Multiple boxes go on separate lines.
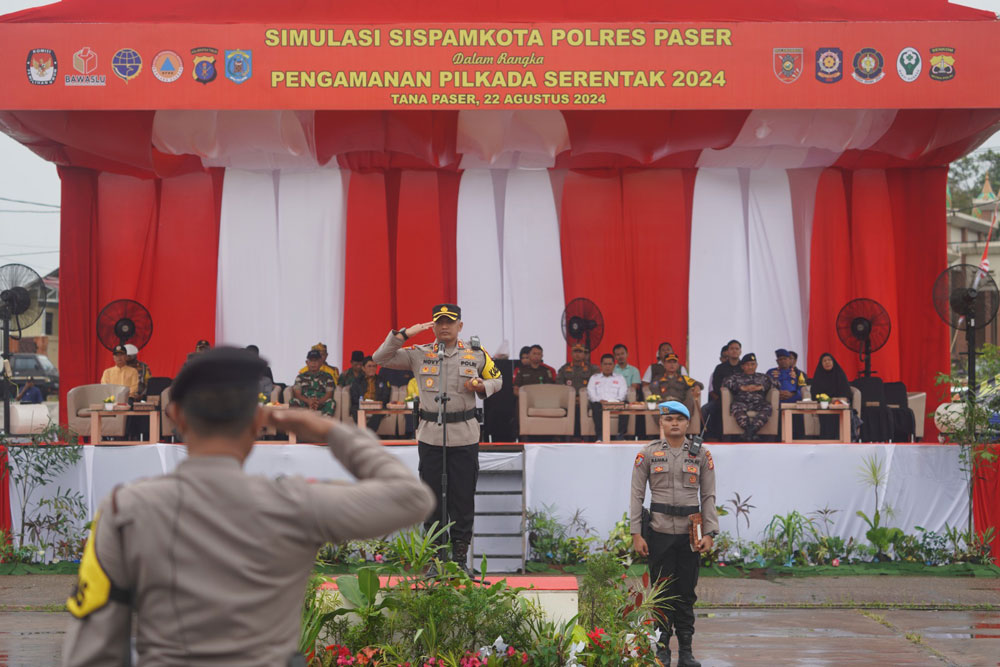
top-left (0, 0), bottom-right (1000, 275)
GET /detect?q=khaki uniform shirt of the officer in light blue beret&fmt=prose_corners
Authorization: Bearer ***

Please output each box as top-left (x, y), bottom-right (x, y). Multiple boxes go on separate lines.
top-left (629, 438), bottom-right (719, 535)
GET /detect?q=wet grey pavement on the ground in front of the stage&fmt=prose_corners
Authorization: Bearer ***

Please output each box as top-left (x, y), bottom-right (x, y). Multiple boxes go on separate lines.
top-left (0, 575), bottom-right (1000, 667)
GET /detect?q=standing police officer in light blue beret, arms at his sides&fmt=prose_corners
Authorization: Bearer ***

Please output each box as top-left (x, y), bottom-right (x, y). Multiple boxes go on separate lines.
top-left (629, 401), bottom-right (719, 667)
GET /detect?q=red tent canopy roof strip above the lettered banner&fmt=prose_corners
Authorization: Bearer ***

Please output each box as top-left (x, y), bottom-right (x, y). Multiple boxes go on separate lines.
top-left (0, 0), bottom-right (996, 23)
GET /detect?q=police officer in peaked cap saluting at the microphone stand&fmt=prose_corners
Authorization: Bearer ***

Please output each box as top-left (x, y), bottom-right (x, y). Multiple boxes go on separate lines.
top-left (372, 303), bottom-right (503, 567)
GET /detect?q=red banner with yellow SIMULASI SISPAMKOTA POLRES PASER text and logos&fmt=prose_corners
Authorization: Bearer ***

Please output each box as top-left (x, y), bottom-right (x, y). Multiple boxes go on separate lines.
top-left (0, 21), bottom-right (1000, 109)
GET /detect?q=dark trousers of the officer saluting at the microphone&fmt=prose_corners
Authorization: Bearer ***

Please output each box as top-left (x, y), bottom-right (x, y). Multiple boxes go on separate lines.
top-left (417, 442), bottom-right (479, 544)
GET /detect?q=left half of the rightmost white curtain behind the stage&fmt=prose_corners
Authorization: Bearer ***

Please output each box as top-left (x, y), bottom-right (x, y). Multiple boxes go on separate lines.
top-left (688, 169), bottom-right (753, 386)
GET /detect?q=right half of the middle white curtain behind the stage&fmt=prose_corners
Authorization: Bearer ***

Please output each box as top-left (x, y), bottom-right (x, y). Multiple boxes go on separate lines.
top-left (503, 170), bottom-right (564, 362)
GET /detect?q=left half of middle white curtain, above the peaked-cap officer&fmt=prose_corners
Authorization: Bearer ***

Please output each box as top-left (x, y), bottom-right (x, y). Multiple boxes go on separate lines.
top-left (455, 169), bottom-right (510, 354)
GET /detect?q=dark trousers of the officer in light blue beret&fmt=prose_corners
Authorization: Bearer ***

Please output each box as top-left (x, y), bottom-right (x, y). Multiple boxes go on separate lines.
top-left (649, 531), bottom-right (701, 634)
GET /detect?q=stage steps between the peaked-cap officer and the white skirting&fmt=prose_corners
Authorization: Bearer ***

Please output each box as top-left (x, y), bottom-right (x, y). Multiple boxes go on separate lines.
top-left (470, 451), bottom-right (526, 574)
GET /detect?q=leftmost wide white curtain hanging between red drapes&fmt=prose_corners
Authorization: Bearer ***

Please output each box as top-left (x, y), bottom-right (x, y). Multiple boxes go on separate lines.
top-left (216, 169), bottom-right (346, 383)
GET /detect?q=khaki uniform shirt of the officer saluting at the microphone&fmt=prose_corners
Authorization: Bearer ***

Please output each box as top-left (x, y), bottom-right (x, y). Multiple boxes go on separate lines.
top-left (372, 332), bottom-right (503, 447)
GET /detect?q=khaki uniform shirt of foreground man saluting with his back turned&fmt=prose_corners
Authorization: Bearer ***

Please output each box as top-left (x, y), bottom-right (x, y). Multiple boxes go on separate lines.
top-left (63, 425), bottom-right (434, 667)
